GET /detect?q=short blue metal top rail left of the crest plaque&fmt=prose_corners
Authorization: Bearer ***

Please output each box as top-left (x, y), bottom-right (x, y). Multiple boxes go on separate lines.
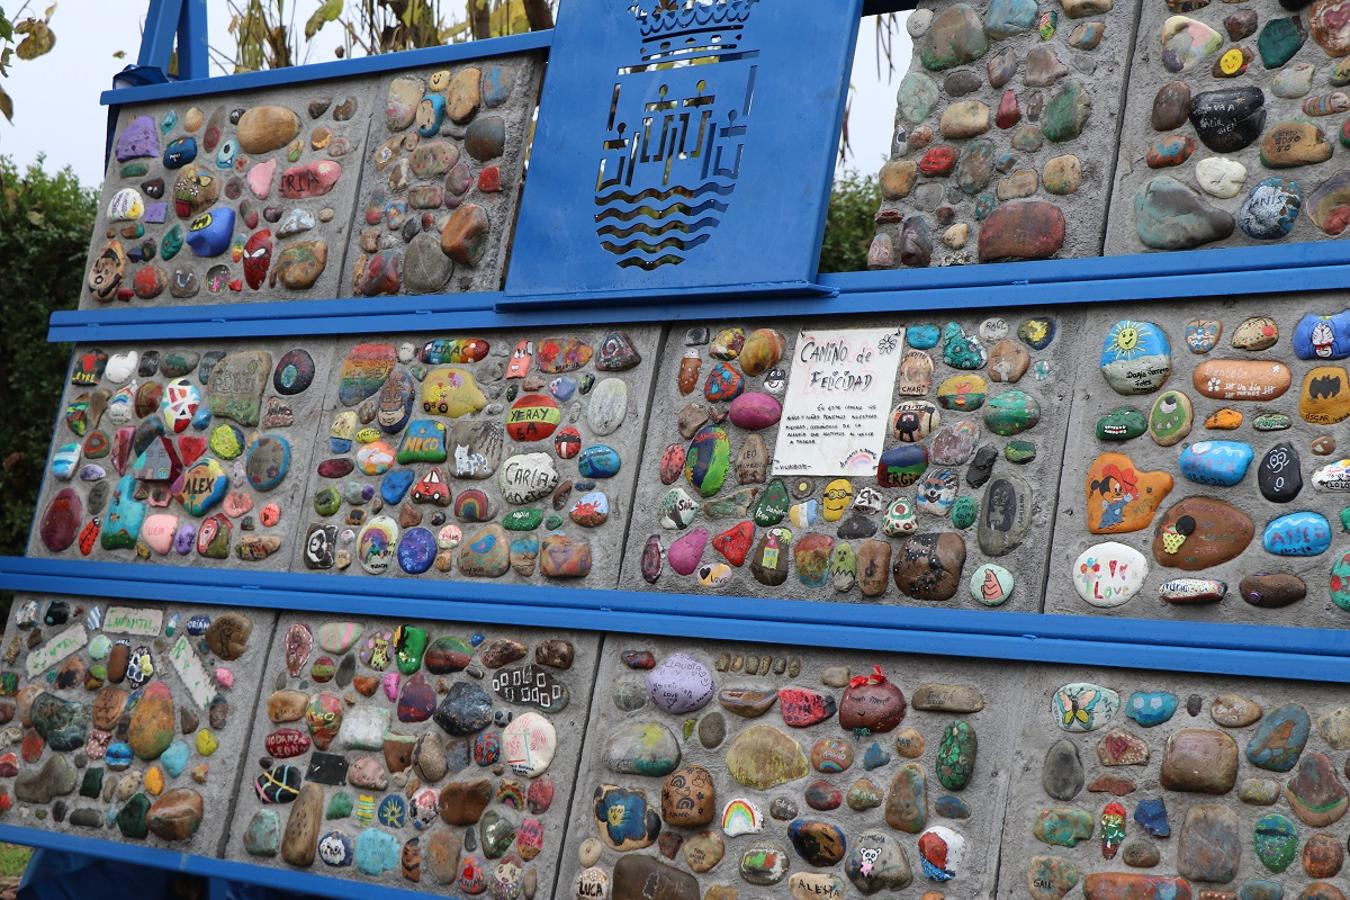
top-left (99, 28), bottom-right (554, 107)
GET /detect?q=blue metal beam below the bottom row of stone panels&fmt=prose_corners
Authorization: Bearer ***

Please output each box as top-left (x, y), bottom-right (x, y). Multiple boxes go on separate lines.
top-left (0, 824), bottom-right (427, 900)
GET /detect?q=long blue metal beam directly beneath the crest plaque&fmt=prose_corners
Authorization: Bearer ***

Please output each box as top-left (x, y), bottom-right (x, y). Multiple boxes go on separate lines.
top-left (47, 242), bottom-right (1350, 343)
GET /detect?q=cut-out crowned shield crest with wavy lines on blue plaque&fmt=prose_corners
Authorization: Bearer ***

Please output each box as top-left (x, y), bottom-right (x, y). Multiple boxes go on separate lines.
top-left (595, 0), bottom-right (759, 271)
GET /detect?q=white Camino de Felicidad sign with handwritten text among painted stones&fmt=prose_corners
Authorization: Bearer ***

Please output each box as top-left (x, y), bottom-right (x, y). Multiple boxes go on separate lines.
top-left (774, 328), bottom-right (905, 476)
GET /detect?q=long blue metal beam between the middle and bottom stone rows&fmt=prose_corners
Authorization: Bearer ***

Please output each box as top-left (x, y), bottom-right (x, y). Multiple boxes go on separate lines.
top-left (0, 557), bottom-right (1350, 683)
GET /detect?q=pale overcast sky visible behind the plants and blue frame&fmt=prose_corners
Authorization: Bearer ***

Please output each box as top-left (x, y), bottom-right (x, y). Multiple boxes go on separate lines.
top-left (0, 0), bottom-right (910, 186)
